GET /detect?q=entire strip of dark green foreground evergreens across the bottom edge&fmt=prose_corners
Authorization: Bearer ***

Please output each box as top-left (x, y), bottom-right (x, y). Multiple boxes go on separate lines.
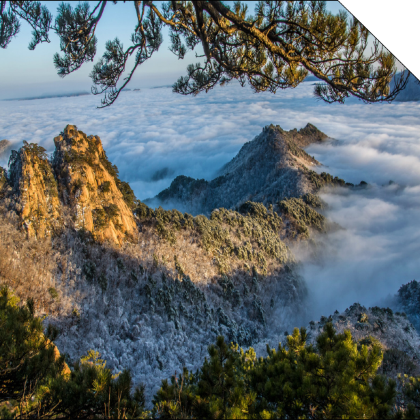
top-left (0, 288), bottom-right (420, 419)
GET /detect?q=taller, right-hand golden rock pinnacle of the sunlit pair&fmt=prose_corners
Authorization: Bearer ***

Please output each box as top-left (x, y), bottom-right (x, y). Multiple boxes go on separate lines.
top-left (53, 125), bottom-right (137, 243)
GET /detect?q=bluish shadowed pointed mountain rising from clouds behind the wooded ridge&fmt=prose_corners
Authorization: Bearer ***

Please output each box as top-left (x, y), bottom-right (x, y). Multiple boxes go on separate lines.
top-left (146, 124), bottom-right (328, 214)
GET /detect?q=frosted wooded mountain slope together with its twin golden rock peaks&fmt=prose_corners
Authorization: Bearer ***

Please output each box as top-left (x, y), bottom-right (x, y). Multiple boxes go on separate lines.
top-left (0, 125), bottom-right (316, 398)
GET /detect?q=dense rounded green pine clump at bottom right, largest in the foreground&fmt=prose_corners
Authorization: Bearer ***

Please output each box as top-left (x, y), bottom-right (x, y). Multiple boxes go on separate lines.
top-left (250, 323), bottom-right (396, 418)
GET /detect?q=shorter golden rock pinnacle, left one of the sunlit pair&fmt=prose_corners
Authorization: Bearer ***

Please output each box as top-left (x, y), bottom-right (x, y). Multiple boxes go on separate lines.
top-left (9, 142), bottom-right (61, 238)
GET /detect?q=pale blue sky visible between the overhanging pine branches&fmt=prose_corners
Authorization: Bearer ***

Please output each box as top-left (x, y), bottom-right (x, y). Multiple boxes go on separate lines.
top-left (0, 1), bottom-right (400, 99)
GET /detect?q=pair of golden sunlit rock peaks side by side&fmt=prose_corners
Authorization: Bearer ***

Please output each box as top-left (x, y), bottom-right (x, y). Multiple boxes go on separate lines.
top-left (4, 125), bottom-right (137, 244)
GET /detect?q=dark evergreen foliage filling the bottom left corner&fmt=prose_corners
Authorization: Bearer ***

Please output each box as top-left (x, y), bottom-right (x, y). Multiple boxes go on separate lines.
top-left (0, 287), bottom-right (147, 418)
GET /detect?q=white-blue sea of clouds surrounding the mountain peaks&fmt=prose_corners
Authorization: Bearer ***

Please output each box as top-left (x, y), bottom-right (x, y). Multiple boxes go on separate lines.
top-left (0, 82), bottom-right (420, 317)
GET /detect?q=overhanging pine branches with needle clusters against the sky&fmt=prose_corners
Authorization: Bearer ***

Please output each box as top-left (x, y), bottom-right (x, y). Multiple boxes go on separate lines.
top-left (0, 1), bottom-right (409, 107)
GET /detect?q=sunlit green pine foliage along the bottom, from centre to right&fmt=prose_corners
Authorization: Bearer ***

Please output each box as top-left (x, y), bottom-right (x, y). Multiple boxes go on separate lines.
top-left (154, 323), bottom-right (401, 418)
